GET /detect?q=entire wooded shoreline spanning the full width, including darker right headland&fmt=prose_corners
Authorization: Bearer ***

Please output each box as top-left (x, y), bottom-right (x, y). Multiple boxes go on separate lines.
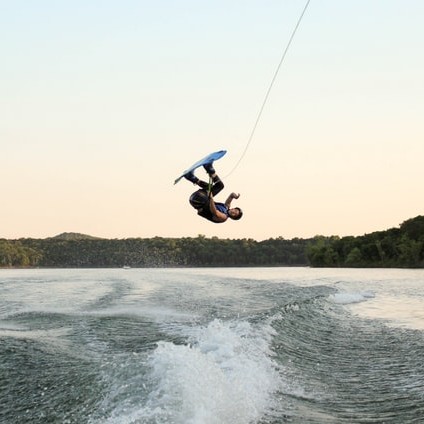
top-left (0, 216), bottom-right (424, 268)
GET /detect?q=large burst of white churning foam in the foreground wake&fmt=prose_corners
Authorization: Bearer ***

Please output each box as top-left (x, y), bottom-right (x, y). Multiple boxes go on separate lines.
top-left (102, 320), bottom-right (281, 424)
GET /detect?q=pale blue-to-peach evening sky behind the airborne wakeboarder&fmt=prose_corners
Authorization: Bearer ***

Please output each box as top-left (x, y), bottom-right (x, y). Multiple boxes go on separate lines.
top-left (0, 0), bottom-right (424, 240)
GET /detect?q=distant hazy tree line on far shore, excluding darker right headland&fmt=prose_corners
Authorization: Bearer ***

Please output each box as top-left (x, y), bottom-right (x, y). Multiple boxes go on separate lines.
top-left (0, 234), bottom-right (308, 268)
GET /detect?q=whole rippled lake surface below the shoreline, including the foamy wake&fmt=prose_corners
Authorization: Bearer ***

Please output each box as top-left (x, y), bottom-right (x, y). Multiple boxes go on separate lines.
top-left (0, 268), bottom-right (424, 424)
